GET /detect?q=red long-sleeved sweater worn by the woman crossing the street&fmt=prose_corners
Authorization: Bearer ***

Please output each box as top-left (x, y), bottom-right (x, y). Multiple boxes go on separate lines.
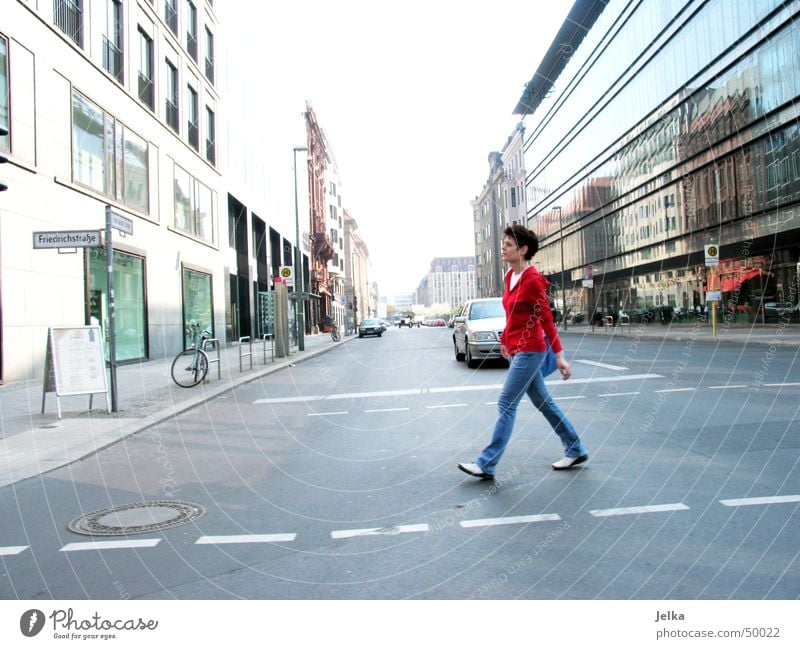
top-left (500, 266), bottom-right (563, 354)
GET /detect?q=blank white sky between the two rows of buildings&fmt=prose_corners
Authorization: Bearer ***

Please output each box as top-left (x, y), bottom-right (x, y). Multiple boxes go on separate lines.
top-left (228, 0), bottom-right (572, 296)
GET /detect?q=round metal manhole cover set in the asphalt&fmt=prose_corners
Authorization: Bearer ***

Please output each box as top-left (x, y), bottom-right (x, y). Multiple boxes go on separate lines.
top-left (67, 500), bottom-right (206, 536)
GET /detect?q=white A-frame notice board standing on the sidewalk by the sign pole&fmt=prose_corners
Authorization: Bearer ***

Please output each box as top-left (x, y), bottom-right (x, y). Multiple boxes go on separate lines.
top-left (42, 325), bottom-right (111, 418)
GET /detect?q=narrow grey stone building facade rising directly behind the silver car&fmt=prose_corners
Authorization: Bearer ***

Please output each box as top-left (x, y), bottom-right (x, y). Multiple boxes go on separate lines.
top-left (472, 151), bottom-right (506, 297)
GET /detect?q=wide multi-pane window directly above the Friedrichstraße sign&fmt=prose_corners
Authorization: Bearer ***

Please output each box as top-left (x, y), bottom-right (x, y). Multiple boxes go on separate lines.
top-left (72, 92), bottom-right (150, 214)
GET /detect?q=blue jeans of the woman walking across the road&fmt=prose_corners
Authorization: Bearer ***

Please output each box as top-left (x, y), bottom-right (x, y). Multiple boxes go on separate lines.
top-left (476, 352), bottom-right (586, 474)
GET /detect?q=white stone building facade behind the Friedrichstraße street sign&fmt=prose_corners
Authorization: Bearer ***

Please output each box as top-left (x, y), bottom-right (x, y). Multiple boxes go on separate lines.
top-left (0, 0), bottom-right (229, 381)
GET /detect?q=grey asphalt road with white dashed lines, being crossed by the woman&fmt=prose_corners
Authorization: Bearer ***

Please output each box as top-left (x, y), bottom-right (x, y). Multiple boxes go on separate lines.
top-left (0, 328), bottom-right (800, 600)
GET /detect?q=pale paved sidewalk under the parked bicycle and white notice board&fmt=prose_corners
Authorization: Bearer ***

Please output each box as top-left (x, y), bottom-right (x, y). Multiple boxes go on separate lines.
top-left (0, 334), bottom-right (351, 487)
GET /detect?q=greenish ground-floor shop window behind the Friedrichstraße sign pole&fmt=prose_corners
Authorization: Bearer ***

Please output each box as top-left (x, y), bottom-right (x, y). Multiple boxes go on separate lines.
top-left (88, 248), bottom-right (147, 361)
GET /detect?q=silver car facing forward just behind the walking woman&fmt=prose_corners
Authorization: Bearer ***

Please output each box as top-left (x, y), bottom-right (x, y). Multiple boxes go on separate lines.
top-left (453, 297), bottom-right (506, 367)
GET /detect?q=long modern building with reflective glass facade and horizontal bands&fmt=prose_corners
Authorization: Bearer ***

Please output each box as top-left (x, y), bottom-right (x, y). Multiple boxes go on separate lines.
top-left (515, 0), bottom-right (800, 321)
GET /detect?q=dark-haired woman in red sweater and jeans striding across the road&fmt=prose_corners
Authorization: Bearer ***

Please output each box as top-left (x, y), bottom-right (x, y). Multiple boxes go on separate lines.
top-left (458, 225), bottom-right (589, 480)
